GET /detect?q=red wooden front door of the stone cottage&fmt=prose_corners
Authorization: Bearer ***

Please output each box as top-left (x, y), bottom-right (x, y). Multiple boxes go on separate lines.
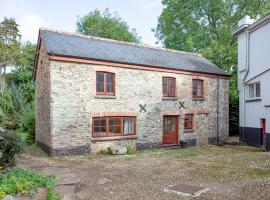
top-left (163, 116), bottom-right (178, 144)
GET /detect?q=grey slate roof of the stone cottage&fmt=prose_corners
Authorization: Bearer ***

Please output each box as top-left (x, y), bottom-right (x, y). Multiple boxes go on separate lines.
top-left (40, 29), bottom-right (228, 75)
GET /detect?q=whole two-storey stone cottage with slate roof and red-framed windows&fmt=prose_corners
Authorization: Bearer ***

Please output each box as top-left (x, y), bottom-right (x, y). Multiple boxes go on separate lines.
top-left (33, 29), bottom-right (229, 155)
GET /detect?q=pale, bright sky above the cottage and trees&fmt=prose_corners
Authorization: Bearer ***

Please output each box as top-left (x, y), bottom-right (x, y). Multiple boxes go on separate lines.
top-left (0, 0), bottom-right (163, 45)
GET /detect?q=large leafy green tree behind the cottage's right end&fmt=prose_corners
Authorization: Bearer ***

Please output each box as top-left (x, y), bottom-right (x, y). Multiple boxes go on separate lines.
top-left (154, 0), bottom-right (270, 102)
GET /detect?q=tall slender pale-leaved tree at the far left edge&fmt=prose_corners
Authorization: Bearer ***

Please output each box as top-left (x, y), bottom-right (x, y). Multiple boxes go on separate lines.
top-left (0, 17), bottom-right (21, 92)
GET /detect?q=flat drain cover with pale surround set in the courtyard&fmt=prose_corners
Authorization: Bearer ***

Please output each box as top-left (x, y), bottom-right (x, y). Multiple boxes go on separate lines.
top-left (164, 184), bottom-right (209, 197)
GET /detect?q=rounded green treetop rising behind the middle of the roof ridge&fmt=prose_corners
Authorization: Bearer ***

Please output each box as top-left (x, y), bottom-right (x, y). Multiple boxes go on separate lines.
top-left (77, 9), bottom-right (140, 43)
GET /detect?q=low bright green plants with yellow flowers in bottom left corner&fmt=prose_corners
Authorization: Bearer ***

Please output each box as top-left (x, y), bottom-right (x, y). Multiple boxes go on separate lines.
top-left (0, 168), bottom-right (60, 200)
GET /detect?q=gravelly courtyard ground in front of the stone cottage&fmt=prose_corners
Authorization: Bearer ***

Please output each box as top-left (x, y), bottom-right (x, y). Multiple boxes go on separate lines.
top-left (18, 145), bottom-right (270, 200)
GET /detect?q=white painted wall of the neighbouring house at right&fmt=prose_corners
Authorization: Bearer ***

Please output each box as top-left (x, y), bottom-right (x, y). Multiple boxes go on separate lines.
top-left (238, 18), bottom-right (270, 133)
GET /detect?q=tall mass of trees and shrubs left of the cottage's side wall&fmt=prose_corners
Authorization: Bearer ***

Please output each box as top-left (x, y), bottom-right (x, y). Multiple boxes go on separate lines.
top-left (0, 18), bottom-right (35, 132)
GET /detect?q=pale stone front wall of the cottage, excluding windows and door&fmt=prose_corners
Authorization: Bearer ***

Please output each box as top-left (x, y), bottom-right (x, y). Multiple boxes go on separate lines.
top-left (43, 61), bottom-right (229, 155)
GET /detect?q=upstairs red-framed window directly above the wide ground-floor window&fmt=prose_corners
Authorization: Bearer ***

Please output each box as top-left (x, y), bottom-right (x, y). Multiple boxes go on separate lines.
top-left (96, 72), bottom-right (115, 96)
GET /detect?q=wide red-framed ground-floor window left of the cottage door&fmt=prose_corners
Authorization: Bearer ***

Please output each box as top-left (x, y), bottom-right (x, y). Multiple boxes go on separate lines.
top-left (93, 117), bottom-right (136, 137)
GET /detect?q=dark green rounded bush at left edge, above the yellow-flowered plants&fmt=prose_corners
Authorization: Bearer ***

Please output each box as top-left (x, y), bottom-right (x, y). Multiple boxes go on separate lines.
top-left (0, 131), bottom-right (21, 165)
